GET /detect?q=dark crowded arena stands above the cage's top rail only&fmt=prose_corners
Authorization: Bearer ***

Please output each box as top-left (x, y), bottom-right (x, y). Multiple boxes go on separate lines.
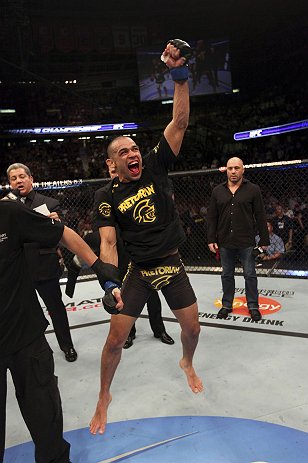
top-left (0, 76), bottom-right (308, 183)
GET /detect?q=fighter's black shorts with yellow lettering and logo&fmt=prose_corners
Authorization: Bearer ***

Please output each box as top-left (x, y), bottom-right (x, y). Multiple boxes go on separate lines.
top-left (121, 253), bottom-right (197, 318)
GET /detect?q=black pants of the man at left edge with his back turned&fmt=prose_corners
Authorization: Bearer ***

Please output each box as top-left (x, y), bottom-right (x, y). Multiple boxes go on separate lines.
top-left (0, 336), bottom-right (70, 463)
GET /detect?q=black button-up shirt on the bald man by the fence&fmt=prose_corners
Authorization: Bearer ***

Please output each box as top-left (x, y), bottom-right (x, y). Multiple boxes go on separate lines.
top-left (207, 179), bottom-right (269, 249)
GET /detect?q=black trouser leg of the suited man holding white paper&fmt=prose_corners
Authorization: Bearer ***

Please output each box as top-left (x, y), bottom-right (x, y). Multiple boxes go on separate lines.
top-left (34, 278), bottom-right (73, 352)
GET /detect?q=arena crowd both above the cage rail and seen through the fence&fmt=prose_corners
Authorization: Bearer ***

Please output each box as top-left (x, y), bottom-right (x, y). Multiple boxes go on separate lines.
top-left (0, 74), bottom-right (308, 268)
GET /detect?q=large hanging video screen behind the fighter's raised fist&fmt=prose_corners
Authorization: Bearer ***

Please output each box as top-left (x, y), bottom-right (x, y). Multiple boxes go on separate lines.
top-left (137, 39), bottom-right (232, 101)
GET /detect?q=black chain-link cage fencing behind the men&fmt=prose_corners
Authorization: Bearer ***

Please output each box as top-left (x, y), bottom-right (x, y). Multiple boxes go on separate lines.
top-left (0, 160), bottom-right (308, 278)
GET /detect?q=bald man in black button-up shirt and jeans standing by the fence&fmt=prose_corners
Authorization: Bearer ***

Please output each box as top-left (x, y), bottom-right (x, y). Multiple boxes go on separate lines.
top-left (207, 158), bottom-right (269, 321)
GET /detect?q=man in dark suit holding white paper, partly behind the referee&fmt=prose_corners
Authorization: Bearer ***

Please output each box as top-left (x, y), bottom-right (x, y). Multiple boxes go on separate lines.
top-left (7, 163), bottom-right (77, 362)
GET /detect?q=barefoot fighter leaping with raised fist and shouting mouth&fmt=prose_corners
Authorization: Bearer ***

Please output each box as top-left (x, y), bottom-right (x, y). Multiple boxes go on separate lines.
top-left (90, 40), bottom-right (203, 434)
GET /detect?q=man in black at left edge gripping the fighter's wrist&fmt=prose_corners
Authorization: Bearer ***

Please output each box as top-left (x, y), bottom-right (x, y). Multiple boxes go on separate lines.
top-left (0, 199), bottom-right (123, 463)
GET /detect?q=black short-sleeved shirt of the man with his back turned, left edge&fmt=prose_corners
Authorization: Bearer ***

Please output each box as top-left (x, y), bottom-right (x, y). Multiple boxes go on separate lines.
top-left (0, 200), bottom-right (64, 357)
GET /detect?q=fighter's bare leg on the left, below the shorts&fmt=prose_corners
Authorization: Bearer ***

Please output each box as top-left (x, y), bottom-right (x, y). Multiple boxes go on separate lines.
top-left (90, 314), bottom-right (137, 434)
